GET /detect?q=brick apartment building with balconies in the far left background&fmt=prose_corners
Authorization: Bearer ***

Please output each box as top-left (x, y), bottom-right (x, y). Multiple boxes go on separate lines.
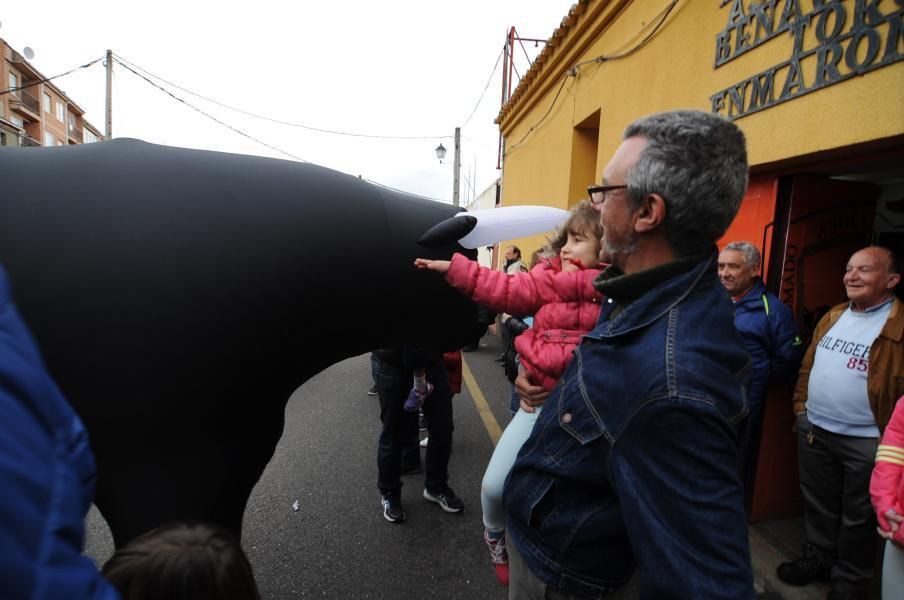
top-left (0, 38), bottom-right (103, 146)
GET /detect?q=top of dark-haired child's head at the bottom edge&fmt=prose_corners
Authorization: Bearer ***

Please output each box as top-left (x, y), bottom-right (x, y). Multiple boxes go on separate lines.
top-left (102, 522), bottom-right (260, 600)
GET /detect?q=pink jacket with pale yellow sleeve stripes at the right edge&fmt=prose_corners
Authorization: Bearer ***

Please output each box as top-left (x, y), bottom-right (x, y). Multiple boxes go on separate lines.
top-left (869, 396), bottom-right (904, 544)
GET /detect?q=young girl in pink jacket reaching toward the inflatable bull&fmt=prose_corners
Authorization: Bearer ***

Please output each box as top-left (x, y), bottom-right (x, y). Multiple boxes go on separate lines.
top-left (414, 202), bottom-right (602, 585)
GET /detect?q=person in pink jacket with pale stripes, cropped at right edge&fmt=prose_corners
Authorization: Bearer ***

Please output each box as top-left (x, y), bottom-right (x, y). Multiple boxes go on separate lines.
top-left (869, 396), bottom-right (904, 598)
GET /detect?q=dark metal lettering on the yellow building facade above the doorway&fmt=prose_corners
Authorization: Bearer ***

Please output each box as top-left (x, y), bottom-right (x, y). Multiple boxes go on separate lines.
top-left (710, 0), bottom-right (904, 119)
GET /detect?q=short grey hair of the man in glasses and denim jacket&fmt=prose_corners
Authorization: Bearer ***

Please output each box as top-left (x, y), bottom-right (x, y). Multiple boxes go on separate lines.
top-left (624, 110), bottom-right (747, 257)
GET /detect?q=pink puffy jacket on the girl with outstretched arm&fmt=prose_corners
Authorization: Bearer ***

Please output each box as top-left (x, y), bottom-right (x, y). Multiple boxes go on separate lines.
top-left (446, 254), bottom-right (603, 390)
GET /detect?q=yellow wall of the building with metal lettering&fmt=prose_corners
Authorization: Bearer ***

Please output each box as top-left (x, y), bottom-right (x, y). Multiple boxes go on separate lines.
top-left (500, 0), bottom-right (904, 256)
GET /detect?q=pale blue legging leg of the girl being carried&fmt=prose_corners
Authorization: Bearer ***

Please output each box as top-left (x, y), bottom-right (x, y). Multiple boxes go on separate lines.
top-left (480, 408), bottom-right (540, 531)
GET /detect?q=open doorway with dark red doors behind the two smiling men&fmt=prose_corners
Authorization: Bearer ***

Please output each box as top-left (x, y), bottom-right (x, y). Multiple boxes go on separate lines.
top-left (720, 147), bottom-right (904, 522)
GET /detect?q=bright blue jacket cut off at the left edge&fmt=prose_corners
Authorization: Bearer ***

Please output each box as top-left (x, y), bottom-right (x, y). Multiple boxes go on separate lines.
top-left (0, 267), bottom-right (119, 600)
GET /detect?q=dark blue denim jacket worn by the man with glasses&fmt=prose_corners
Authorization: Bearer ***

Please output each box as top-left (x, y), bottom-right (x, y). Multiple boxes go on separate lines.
top-left (504, 252), bottom-right (753, 600)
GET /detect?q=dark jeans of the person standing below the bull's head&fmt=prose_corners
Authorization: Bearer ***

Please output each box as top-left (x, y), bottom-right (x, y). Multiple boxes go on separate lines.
top-left (377, 360), bottom-right (454, 494)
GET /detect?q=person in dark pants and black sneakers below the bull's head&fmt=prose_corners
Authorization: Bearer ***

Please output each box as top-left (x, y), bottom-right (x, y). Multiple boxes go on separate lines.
top-left (375, 345), bottom-right (464, 523)
